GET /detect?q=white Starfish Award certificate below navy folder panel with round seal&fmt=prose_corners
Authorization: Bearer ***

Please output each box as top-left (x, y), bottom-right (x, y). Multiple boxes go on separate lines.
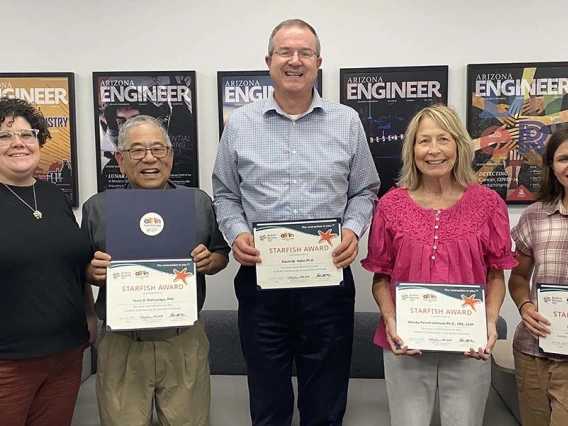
top-left (106, 259), bottom-right (198, 330)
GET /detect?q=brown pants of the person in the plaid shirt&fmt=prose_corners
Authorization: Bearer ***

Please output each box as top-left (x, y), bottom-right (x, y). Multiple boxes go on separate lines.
top-left (514, 351), bottom-right (568, 426)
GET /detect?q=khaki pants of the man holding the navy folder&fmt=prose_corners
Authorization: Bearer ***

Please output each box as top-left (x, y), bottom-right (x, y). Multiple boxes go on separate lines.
top-left (96, 321), bottom-right (211, 426)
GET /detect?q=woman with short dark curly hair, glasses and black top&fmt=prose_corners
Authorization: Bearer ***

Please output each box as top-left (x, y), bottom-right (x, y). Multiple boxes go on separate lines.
top-left (0, 98), bottom-right (96, 426)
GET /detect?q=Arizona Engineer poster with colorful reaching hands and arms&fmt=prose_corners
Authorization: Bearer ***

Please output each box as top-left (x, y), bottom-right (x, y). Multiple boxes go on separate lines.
top-left (467, 62), bottom-right (568, 204)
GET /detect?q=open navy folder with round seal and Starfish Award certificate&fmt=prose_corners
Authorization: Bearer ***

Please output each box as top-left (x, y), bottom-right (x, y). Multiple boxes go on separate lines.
top-left (105, 189), bottom-right (198, 331)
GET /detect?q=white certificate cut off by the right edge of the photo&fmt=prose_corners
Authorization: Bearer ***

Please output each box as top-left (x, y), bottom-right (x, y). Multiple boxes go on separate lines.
top-left (537, 284), bottom-right (568, 355)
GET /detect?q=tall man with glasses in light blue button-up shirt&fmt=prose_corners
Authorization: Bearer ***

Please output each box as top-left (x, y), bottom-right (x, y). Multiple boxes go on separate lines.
top-left (213, 19), bottom-right (380, 426)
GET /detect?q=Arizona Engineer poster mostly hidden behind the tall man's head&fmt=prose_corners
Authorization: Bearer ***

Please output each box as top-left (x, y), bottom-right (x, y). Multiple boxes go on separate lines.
top-left (217, 70), bottom-right (323, 137)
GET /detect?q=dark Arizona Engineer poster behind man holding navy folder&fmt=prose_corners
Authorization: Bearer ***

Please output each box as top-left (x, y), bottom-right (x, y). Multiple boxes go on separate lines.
top-left (93, 71), bottom-right (199, 192)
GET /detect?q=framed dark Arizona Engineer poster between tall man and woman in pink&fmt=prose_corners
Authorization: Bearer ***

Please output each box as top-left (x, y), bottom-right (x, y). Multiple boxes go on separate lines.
top-left (339, 65), bottom-right (448, 197)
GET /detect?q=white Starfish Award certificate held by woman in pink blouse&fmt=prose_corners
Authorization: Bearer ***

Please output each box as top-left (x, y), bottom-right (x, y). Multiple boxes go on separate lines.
top-left (396, 283), bottom-right (487, 352)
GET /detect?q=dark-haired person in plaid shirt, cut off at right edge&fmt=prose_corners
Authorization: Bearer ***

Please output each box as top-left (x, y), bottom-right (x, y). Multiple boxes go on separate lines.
top-left (509, 125), bottom-right (568, 426)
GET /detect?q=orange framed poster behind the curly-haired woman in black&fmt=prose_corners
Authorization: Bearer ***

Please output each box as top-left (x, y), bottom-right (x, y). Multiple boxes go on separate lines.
top-left (0, 73), bottom-right (79, 207)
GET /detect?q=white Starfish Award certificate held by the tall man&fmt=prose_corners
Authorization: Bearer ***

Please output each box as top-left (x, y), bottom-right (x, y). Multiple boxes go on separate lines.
top-left (254, 219), bottom-right (343, 290)
